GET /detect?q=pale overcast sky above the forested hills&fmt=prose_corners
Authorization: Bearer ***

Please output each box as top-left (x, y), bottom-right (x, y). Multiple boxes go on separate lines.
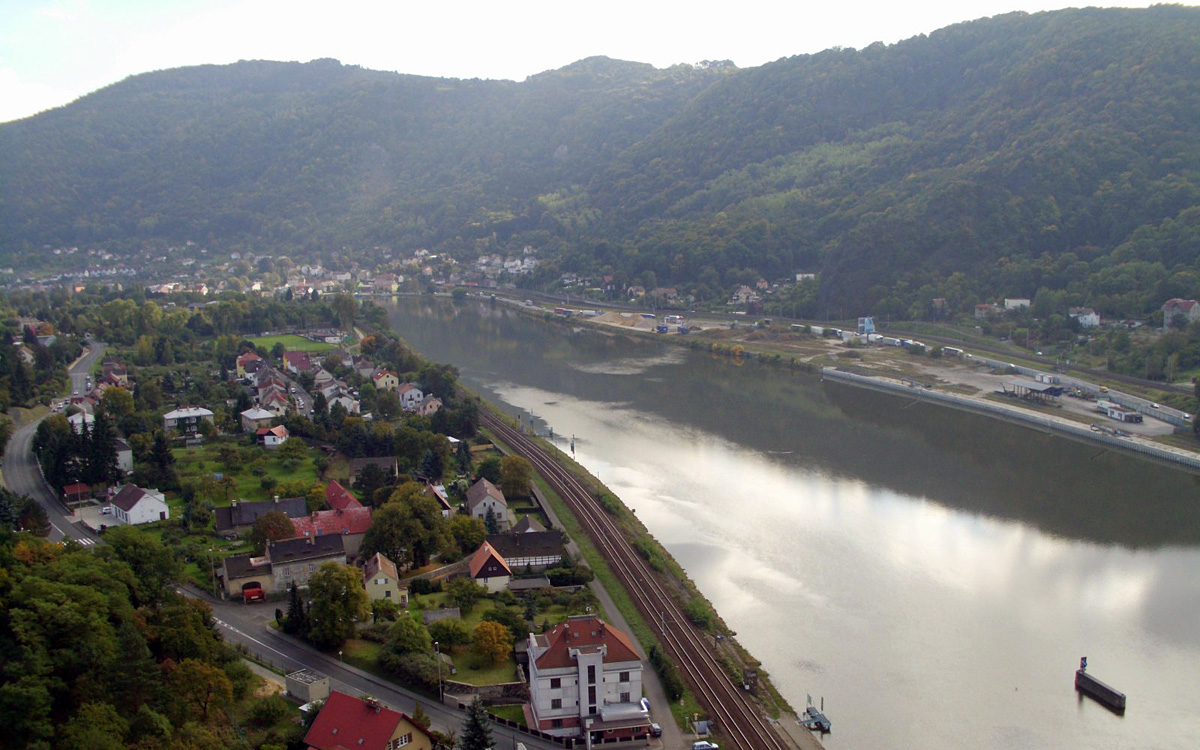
top-left (0, 0), bottom-right (1150, 122)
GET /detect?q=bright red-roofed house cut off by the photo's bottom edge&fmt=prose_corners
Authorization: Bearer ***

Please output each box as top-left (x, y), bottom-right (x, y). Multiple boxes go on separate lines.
top-left (304, 690), bottom-right (433, 750)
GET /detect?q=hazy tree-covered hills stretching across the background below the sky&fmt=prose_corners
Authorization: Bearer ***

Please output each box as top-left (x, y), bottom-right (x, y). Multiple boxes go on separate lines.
top-left (0, 6), bottom-right (1200, 317)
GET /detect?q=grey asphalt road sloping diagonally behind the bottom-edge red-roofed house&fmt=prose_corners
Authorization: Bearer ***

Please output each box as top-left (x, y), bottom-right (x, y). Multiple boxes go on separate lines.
top-left (179, 586), bottom-right (562, 750)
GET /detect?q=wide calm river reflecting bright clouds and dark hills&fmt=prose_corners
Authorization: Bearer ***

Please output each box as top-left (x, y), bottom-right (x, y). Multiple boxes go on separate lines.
top-left (389, 299), bottom-right (1200, 750)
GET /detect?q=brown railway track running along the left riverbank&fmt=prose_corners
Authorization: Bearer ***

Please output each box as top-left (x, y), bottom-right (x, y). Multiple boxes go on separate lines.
top-left (480, 410), bottom-right (793, 750)
